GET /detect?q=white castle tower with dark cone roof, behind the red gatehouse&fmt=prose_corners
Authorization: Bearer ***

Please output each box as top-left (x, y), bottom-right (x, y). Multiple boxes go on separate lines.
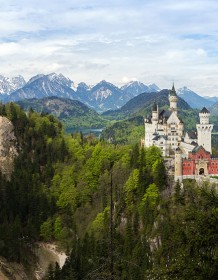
top-left (196, 107), bottom-right (213, 153)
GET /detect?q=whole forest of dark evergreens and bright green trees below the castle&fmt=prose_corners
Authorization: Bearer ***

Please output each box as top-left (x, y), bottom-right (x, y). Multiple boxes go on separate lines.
top-left (0, 103), bottom-right (218, 280)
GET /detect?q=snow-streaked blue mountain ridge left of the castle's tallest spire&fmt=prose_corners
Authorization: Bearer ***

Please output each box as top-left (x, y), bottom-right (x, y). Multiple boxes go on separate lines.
top-left (0, 73), bottom-right (159, 112)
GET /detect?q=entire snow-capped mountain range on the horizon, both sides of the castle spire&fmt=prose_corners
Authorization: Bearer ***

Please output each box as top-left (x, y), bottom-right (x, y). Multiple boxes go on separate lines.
top-left (0, 73), bottom-right (218, 112)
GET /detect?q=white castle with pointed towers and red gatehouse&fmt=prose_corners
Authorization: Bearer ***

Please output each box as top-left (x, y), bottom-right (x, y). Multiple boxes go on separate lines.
top-left (144, 85), bottom-right (218, 181)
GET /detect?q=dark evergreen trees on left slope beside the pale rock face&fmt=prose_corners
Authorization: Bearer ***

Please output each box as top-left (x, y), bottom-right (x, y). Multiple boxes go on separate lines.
top-left (0, 103), bottom-right (68, 261)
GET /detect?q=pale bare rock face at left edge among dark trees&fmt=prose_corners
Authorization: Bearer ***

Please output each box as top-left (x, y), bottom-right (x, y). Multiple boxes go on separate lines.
top-left (0, 116), bottom-right (18, 180)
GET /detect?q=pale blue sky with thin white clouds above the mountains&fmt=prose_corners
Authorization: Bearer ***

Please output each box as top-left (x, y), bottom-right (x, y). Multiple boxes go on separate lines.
top-left (0, 0), bottom-right (218, 96)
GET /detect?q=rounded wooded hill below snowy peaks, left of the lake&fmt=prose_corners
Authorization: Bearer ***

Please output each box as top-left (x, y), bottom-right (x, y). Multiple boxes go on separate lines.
top-left (17, 96), bottom-right (107, 129)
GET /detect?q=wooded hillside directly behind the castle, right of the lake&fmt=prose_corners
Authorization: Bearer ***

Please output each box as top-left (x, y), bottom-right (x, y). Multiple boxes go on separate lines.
top-left (102, 90), bottom-right (199, 144)
